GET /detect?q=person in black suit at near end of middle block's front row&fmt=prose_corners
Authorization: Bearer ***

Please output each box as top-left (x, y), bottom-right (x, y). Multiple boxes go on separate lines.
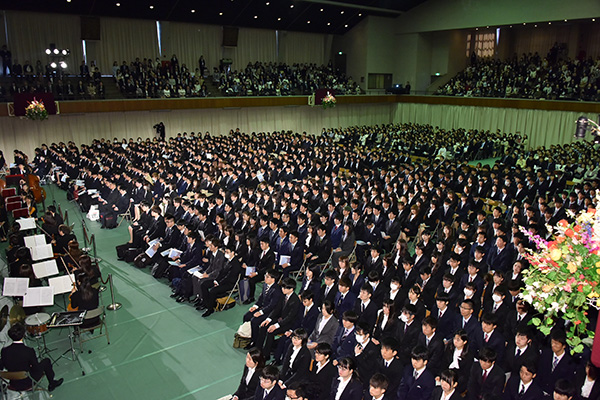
top-left (197, 243), bottom-right (242, 318)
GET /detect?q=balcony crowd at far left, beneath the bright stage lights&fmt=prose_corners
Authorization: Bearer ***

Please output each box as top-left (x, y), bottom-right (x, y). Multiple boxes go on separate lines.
top-left (0, 60), bottom-right (106, 101)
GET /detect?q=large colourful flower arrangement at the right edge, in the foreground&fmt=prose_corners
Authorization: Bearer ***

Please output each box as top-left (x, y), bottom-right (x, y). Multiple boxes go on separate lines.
top-left (520, 194), bottom-right (600, 353)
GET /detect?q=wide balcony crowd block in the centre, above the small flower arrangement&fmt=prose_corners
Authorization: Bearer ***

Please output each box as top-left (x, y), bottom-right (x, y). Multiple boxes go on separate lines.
top-left (213, 61), bottom-right (361, 96)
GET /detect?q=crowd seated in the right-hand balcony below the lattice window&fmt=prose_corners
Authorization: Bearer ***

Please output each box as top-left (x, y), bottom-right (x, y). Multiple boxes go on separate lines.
top-left (436, 44), bottom-right (600, 101)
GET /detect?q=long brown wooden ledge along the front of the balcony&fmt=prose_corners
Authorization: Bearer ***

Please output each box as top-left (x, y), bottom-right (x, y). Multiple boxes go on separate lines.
top-left (0, 95), bottom-right (600, 117)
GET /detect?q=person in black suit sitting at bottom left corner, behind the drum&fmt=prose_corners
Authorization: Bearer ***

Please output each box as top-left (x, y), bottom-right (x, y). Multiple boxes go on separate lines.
top-left (0, 323), bottom-right (63, 392)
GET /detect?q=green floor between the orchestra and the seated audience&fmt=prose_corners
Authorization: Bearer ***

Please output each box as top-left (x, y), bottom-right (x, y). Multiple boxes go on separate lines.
top-left (0, 185), bottom-right (248, 400)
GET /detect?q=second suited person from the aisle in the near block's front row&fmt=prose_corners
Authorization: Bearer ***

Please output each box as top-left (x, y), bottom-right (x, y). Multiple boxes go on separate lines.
top-left (255, 277), bottom-right (308, 361)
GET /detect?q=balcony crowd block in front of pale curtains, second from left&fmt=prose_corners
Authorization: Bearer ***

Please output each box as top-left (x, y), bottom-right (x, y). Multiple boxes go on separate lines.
top-left (112, 54), bottom-right (210, 98)
